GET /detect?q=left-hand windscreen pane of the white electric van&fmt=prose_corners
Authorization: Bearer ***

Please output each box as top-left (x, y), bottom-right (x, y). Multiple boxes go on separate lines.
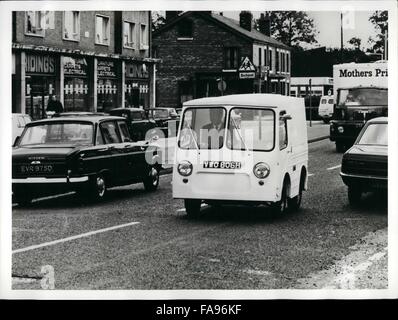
top-left (178, 107), bottom-right (226, 149)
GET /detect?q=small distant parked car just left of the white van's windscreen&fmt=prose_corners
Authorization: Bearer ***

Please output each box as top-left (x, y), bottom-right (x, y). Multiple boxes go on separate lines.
top-left (148, 108), bottom-right (180, 138)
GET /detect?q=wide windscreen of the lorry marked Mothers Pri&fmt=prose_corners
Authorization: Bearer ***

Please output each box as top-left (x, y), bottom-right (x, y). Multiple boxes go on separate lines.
top-left (338, 88), bottom-right (388, 108)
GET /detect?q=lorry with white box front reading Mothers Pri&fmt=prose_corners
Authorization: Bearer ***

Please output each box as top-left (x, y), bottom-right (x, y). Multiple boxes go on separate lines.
top-left (330, 61), bottom-right (388, 152)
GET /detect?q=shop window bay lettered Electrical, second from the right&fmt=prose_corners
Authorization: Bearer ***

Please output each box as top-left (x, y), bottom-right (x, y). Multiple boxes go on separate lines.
top-left (97, 59), bottom-right (119, 112)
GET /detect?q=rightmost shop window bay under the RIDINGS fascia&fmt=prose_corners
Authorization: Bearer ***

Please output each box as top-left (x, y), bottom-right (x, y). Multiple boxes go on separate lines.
top-left (124, 62), bottom-right (150, 109)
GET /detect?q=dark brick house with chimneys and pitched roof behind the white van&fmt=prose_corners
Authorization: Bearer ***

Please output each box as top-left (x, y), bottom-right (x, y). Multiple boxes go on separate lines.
top-left (152, 11), bottom-right (291, 107)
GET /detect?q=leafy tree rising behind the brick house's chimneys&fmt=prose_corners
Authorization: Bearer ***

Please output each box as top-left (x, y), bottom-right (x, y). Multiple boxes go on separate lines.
top-left (255, 11), bottom-right (318, 49)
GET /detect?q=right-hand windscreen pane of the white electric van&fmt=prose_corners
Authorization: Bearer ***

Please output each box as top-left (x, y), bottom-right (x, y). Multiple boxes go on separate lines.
top-left (227, 108), bottom-right (274, 151)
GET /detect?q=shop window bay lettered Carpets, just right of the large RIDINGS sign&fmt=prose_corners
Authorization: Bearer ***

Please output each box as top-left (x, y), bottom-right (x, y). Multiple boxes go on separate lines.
top-left (62, 57), bottom-right (91, 112)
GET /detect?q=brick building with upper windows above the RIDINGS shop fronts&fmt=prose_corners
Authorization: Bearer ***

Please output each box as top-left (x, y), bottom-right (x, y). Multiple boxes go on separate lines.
top-left (12, 11), bottom-right (156, 119)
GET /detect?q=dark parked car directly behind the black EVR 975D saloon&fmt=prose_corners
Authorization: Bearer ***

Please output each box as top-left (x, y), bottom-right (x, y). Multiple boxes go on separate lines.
top-left (109, 108), bottom-right (157, 141)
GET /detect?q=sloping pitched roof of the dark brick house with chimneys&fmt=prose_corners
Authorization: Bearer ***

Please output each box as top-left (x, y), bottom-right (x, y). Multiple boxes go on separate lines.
top-left (153, 11), bottom-right (291, 50)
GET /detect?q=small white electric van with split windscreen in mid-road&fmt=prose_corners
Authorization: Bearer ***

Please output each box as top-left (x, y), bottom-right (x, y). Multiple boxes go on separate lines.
top-left (173, 94), bottom-right (308, 216)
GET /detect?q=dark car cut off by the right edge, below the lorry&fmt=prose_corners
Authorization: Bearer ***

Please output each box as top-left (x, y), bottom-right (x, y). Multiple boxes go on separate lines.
top-left (340, 117), bottom-right (388, 205)
